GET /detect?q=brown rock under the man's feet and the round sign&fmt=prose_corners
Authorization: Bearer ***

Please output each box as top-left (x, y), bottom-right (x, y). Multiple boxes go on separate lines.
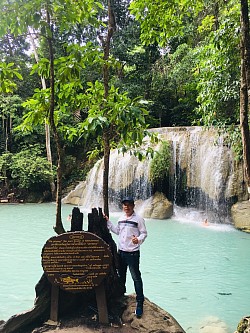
top-left (29, 294), bottom-right (185, 333)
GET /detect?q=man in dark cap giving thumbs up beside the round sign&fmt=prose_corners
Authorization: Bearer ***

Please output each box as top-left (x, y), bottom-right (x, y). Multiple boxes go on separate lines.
top-left (106, 197), bottom-right (147, 318)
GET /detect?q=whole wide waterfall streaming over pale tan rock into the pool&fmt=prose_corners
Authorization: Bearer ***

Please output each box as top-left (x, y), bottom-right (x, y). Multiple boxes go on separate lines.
top-left (63, 127), bottom-right (247, 223)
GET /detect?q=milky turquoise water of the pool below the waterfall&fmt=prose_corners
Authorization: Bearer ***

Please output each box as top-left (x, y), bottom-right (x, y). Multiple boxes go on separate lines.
top-left (0, 204), bottom-right (250, 333)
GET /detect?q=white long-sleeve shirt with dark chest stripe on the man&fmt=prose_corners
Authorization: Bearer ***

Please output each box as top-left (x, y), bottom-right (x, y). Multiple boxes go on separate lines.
top-left (107, 212), bottom-right (147, 252)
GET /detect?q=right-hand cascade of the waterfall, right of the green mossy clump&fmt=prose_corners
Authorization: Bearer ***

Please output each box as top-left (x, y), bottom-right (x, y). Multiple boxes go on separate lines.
top-left (156, 127), bottom-right (246, 223)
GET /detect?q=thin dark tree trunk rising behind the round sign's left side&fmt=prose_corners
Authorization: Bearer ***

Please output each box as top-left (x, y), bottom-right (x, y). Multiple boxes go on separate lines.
top-left (46, 5), bottom-right (65, 234)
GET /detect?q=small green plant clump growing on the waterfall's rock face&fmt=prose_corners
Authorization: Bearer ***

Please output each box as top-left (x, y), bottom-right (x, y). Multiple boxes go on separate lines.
top-left (149, 141), bottom-right (171, 183)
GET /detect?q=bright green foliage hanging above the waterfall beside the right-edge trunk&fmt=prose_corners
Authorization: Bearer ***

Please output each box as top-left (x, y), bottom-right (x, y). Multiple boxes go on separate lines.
top-left (196, 4), bottom-right (240, 126)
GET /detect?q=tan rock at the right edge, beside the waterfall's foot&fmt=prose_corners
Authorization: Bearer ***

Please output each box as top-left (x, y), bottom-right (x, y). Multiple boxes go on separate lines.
top-left (231, 201), bottom-right (250, 232)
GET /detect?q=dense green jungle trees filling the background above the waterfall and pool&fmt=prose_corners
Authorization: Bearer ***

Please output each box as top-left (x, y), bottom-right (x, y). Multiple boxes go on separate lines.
top-left (0, 0), bottom-right (250, 231)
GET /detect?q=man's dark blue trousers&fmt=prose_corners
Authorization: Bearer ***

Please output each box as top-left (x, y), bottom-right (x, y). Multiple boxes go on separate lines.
top-left (118, 250), bottom-right (144, 302)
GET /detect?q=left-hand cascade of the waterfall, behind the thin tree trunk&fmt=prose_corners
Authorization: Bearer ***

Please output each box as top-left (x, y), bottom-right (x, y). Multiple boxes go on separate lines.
top-left (63, 150), bottom-right (152, 210)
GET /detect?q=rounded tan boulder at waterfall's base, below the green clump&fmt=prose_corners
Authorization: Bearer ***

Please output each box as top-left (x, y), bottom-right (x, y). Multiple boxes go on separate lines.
top-left (143, 192), bottom-right (173, 220)
